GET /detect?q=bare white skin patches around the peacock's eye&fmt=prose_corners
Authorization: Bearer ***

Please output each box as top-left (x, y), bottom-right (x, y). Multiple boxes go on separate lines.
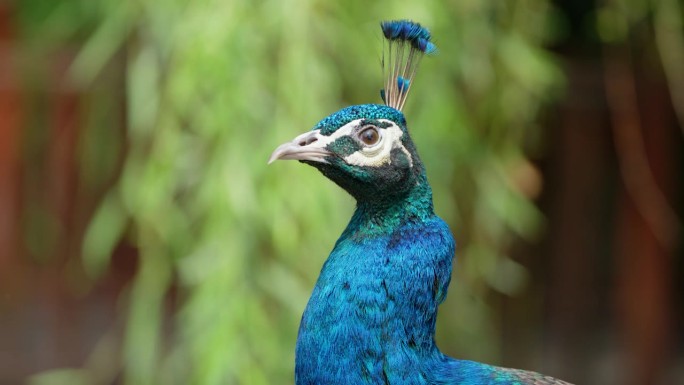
top-left (309, 119), bottom-right (413, 167)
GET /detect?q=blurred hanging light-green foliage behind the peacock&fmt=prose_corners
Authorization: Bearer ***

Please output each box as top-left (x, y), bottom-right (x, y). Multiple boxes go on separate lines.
top-left (22, 0), bottom-right (561, 385)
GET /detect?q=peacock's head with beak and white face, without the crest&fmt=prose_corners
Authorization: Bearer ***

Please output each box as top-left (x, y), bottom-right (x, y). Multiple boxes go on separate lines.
top-left (269, 104), bottom-right (424, 202)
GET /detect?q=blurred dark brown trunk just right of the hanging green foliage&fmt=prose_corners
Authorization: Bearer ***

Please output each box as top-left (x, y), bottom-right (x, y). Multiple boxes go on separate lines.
top-left (544, 51), bottom-right (615, 384)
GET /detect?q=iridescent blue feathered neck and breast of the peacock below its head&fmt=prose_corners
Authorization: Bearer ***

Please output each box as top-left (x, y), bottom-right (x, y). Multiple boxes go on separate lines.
top-left (296, 181), bottom-right (524, 385)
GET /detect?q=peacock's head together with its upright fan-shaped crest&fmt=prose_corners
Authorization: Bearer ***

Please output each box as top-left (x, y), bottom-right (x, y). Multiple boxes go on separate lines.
top-left (269, 20), bottom-right (436, 202)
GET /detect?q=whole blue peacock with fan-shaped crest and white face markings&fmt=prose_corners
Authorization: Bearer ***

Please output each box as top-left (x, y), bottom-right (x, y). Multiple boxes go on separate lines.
top-left (269, 20), bottom-right (568, 385)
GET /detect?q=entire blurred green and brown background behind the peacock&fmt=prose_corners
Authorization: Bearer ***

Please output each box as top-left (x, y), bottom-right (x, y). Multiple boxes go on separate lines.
top-left (0, 0), bottom-right (684, 385)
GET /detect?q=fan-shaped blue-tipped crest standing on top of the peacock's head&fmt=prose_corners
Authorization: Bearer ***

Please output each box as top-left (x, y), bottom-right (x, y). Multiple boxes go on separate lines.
top-left (380, 20), bottom-right (437, 111)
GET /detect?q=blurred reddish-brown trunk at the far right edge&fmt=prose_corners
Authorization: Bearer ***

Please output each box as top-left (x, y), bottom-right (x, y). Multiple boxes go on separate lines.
top-left (604, 42), bottom-right (681, 385)
